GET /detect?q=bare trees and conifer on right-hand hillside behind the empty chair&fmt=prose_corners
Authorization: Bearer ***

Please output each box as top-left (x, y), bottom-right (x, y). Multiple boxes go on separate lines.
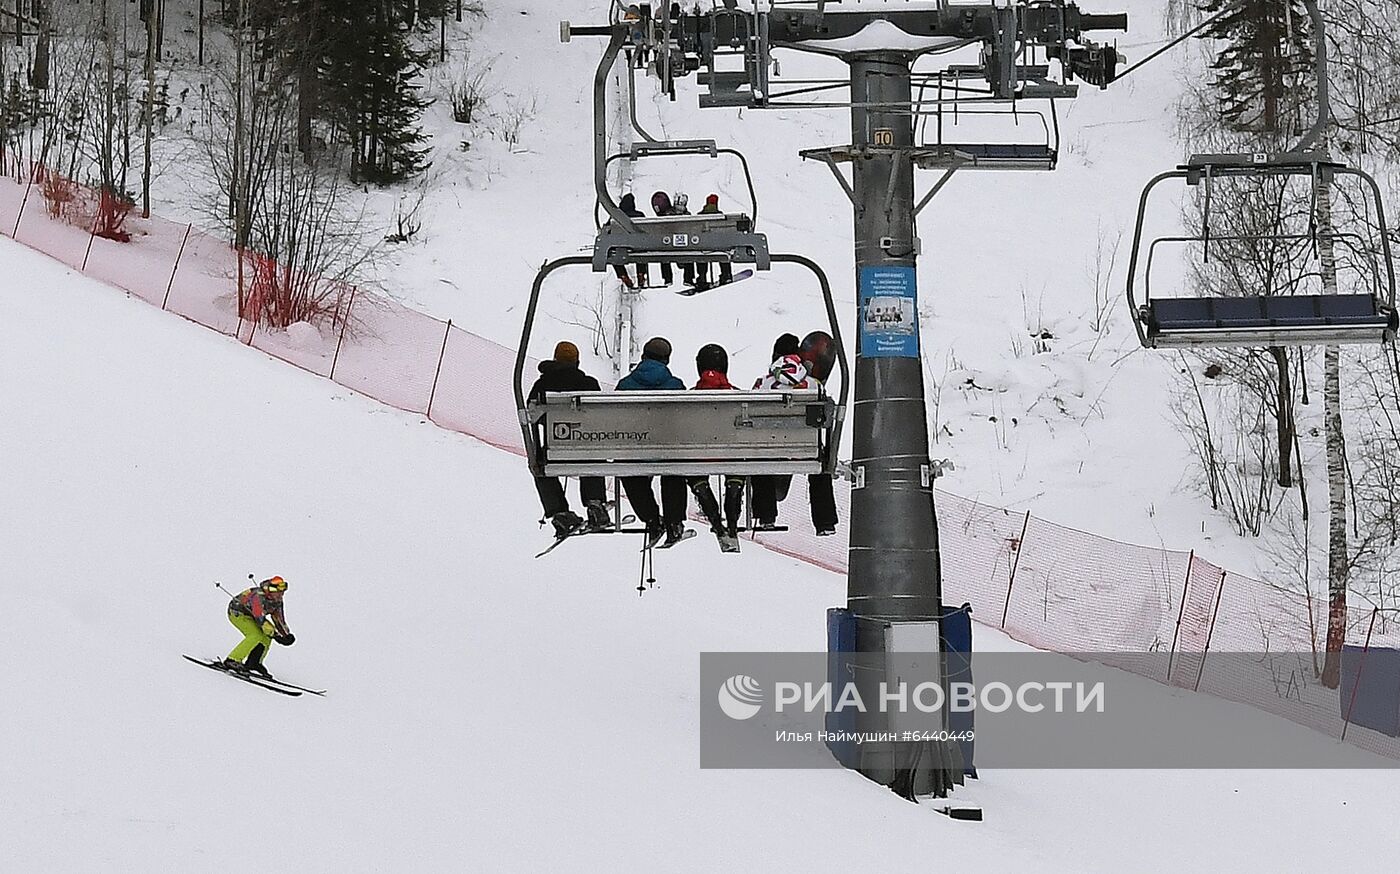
top-left (1169, 0), bottom-right (1400, 686)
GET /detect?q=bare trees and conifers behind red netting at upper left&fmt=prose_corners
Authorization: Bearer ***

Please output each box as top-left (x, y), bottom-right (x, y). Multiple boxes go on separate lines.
top-left (0, 0), bottom-right (480, 325)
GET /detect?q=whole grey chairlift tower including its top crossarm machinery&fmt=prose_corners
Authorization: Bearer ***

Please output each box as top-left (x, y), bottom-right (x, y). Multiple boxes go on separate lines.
top-left (561, 0), bottom-right (1127, 794)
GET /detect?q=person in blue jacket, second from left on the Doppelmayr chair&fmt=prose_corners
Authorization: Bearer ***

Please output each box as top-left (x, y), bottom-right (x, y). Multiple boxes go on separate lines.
top-left (617, 338), bottom-right (724, 546)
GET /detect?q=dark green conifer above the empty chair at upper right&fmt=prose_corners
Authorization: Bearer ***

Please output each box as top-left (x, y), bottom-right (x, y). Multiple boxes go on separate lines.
top-left (1198, 0), bottom-right (1313, 133)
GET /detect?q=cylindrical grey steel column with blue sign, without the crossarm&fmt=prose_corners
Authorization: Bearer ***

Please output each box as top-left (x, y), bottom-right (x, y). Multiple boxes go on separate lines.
top-left (846, 52), bottom-right (942, 621)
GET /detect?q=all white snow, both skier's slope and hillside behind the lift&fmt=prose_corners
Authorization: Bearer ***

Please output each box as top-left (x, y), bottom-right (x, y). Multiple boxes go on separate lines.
top-left (8, 0), bottom-right (1400, 874)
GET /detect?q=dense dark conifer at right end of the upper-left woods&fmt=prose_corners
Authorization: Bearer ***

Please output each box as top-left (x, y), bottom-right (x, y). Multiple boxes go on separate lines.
top-left (318, 0), bottom-right (428, 183)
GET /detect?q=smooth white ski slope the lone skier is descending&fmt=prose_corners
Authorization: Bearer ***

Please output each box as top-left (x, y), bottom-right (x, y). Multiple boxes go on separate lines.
top-left (0, 241), bottom-right (1400, 874)
